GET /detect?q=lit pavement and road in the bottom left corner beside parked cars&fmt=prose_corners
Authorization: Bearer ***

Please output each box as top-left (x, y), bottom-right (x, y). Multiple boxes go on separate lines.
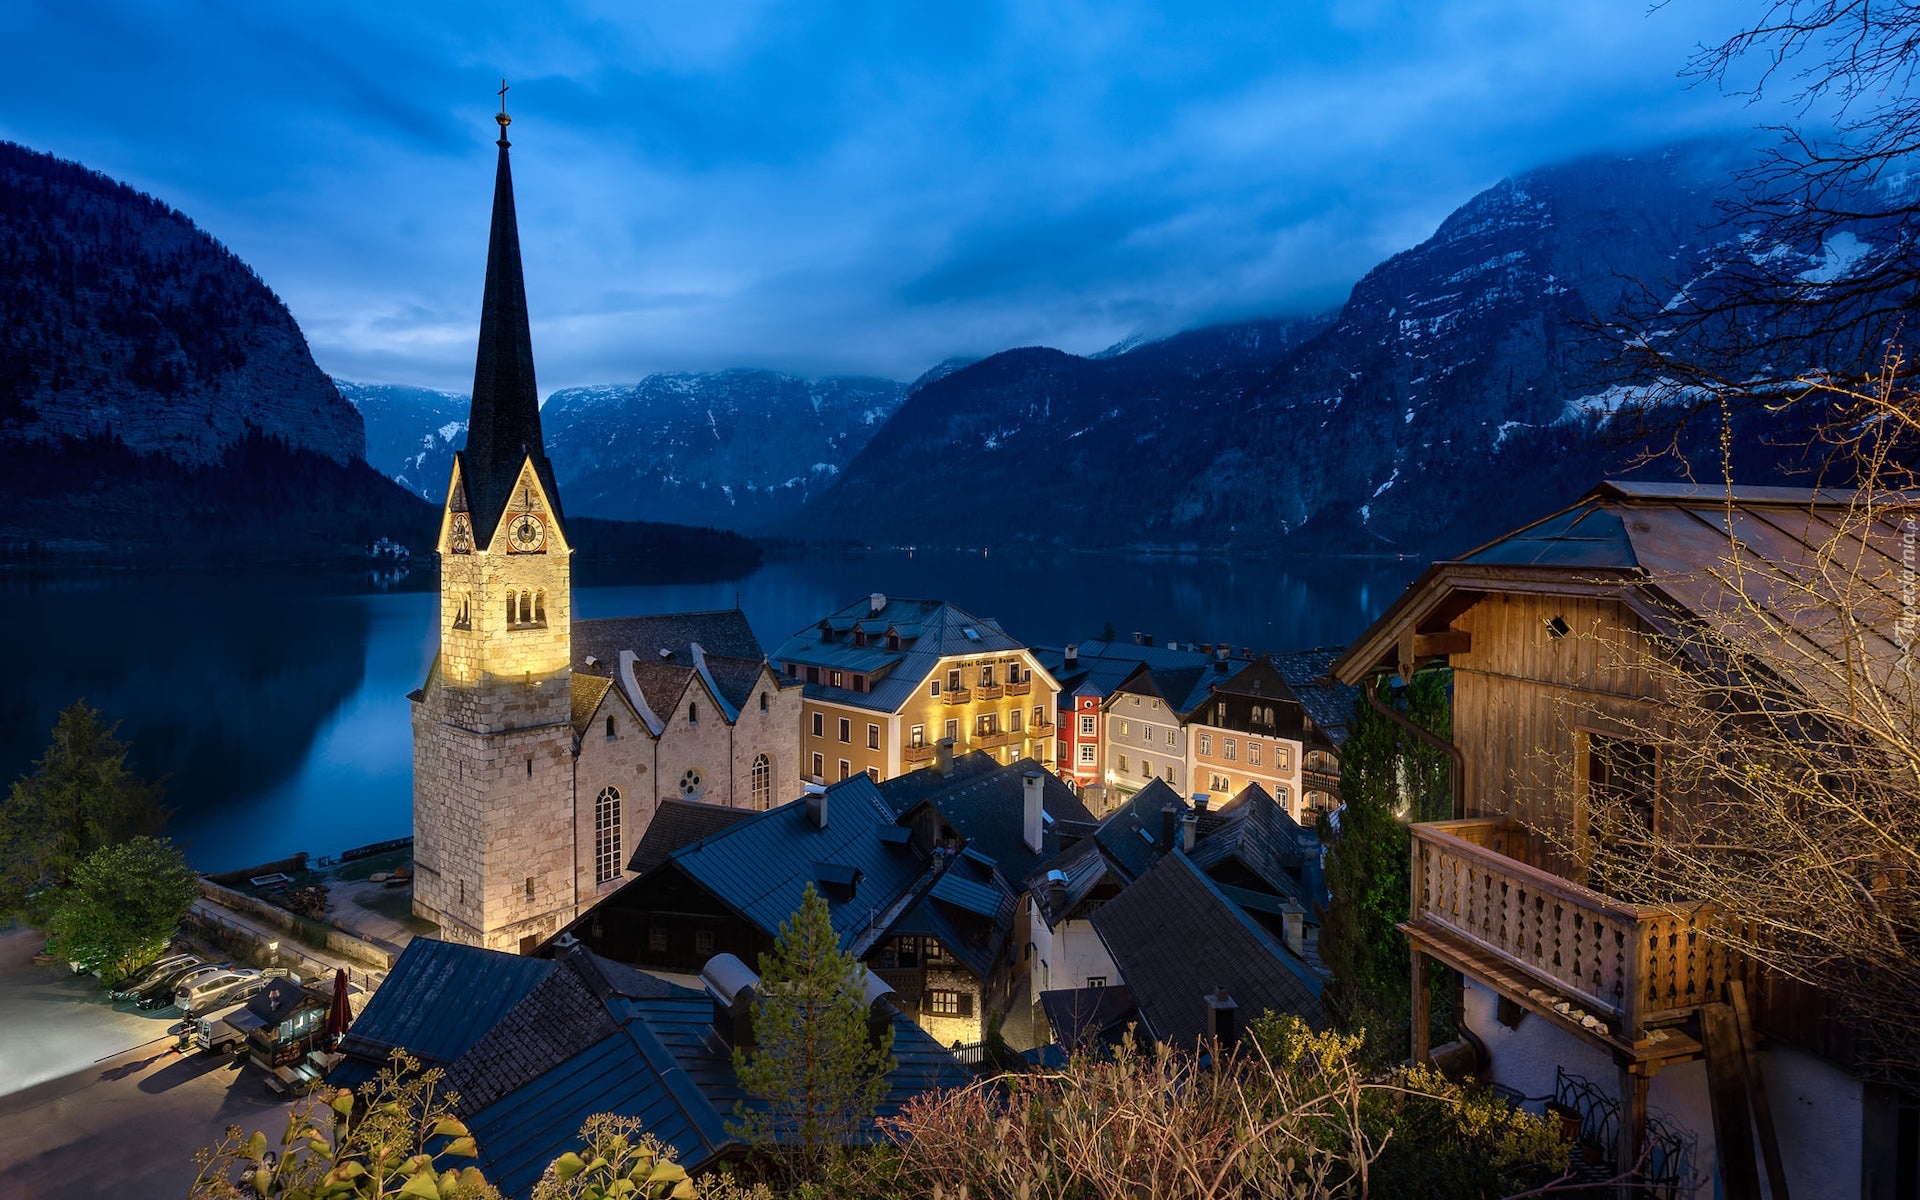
top-left (0, 929), bottom-right (292, 1200)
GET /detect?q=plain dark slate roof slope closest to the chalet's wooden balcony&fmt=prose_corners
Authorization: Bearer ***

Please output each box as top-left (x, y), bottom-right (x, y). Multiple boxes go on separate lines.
top-left (1092, 854), bottom-right (1321, 1044)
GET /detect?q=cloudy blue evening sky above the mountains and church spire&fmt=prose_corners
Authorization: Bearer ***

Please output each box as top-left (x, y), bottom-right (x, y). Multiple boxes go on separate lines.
top-left (0, 0), bottom-right (1761, 390)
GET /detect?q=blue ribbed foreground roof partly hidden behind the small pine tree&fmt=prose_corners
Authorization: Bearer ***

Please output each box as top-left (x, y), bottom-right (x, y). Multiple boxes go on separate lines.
top-left (456, 993), bottom-right (972, 1196)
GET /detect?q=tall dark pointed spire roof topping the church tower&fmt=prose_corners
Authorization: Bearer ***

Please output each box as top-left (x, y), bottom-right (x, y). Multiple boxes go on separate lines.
top-left (459, 102), bottom-right (561, 541)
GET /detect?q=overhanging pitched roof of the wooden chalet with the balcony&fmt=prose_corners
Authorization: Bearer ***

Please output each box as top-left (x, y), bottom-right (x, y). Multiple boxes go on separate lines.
top-left (1334, 480), bottom-right (1920, 702)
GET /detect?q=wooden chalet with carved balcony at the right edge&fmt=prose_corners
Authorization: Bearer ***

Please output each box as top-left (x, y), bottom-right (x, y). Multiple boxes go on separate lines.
top-left (1332, 482), bottom-right (1914, 1200)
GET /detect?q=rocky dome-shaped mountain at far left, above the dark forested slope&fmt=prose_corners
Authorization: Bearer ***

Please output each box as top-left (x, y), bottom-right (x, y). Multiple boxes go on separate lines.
top-left (0, 142), bottom-right (365, 465)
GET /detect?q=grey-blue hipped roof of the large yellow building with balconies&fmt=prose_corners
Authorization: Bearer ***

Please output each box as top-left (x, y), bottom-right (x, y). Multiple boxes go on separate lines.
top-left (772, 597), bottom-right (1025, 712)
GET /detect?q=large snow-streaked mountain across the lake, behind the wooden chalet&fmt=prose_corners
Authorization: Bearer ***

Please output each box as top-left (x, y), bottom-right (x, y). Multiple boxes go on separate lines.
top-left (791, 144), bottom-right (1776, 551)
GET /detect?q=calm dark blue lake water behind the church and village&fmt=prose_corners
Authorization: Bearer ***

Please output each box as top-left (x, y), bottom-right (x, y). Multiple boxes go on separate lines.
top-left (0, 551), bottom-right (1425, 870)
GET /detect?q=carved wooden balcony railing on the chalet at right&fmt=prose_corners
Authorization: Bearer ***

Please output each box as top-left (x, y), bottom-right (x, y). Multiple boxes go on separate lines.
top-left (1411, 820), bottom-right (1745, 1043)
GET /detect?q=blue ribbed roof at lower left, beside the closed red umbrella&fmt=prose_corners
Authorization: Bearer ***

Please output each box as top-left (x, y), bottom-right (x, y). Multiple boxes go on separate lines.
top-left (328, 937), bottom-right (553, 1087)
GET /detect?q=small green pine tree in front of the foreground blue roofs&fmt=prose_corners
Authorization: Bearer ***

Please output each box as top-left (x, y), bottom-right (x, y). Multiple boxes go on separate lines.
top-left (732, 883), bottom-right (893, 1179)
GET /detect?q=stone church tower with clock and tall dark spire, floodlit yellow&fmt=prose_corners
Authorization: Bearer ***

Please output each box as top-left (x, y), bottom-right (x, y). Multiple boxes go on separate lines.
top-left (411, 104), bottom-right (580, 950)
